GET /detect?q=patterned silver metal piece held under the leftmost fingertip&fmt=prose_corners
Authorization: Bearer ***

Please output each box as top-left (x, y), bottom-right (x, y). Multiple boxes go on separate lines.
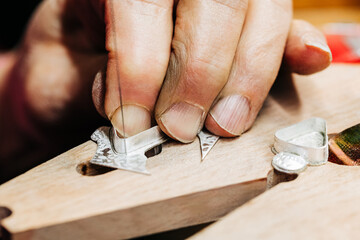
top-left (90, 126), bottom-right (168, 174)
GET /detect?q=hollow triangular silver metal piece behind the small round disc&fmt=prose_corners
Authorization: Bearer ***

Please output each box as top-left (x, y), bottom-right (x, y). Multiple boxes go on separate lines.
top-left (274, 118), bottom-right (329, 165)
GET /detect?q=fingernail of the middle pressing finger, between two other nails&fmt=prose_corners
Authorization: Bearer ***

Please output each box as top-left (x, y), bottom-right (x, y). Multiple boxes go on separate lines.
top-left (160, 102), bottom-right (205, 143)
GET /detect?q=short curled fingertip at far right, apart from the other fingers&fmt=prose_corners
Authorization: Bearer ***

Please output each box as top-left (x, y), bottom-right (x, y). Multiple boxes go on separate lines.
top-left (285, 20), bottom-right (332, 74)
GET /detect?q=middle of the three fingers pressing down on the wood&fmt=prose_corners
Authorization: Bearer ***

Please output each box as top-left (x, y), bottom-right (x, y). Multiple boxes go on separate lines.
top-left (155, 0), bottom-right (247, 142)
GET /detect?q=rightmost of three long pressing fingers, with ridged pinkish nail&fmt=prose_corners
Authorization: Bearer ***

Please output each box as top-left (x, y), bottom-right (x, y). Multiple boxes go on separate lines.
top-left (205, 0), bottom-right (292, 137)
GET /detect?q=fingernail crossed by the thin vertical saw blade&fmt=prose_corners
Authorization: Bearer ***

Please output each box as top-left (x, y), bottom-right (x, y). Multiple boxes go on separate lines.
top-left (111, 105), bottom-right (151, 137)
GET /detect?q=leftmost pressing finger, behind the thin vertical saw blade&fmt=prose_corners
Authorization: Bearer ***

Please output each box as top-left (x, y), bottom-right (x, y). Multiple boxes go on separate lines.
top-left (104, 0), bottom-right (173, 136)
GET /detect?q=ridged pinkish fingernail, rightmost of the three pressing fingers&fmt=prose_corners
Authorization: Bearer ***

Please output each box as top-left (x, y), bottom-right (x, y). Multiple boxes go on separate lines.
top-left (210, 95), bottom-right (250, 135)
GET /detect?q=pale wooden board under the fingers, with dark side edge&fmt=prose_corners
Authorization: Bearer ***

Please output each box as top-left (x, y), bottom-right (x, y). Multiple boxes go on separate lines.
top-left (0, 62), bottom-right (360, 239)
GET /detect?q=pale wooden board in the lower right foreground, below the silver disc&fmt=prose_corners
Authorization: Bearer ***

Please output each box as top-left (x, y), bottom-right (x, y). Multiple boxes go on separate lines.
top-left (190, 163), bottom-right (360, 240)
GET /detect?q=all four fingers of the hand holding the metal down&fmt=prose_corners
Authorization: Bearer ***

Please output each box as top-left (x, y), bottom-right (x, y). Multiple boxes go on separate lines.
top-left (95, 0), bottom-right (331, 142)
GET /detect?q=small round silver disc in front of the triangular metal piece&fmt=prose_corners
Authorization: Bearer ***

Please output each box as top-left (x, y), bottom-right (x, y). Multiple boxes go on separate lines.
top-left (272, 152), bottom-right (308, 174)
